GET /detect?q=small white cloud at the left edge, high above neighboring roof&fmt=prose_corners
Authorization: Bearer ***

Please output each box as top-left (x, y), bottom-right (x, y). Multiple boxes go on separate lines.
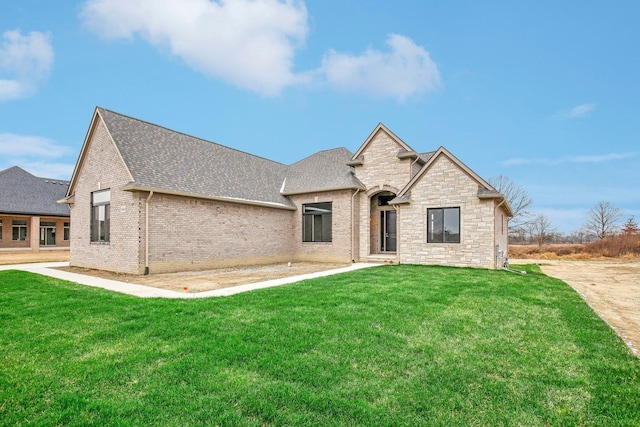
top-left (0, 30), bottom-right (54, 102)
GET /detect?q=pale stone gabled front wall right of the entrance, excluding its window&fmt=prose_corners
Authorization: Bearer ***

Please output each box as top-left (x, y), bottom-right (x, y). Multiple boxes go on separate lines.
top-left (398, 155), bottom-right (495, 268)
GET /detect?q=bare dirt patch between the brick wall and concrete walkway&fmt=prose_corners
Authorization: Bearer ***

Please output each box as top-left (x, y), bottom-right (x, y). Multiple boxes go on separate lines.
top-left (60, 262), bottom-right (351, 292)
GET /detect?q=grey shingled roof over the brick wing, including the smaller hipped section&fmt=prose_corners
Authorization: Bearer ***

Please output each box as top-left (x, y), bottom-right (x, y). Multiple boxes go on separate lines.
top-left (70, 107), bottom-right (362, 209)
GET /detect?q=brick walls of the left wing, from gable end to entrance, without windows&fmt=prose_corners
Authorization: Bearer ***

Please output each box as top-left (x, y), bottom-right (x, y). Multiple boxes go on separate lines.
top-left (70, 115), bottom-right (360, 274)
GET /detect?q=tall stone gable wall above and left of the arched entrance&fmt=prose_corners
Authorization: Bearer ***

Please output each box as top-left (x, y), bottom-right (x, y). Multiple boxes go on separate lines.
top-left (355, 130), bottom-right (413, 261)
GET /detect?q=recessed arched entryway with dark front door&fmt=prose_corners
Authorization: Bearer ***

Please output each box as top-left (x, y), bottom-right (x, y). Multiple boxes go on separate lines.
top-left (369, 191), bottom-right (398, 254)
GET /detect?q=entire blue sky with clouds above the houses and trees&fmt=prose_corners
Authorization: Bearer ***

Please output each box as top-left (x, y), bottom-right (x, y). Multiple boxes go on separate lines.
top-left (0, 0), bottom-right (640, 232)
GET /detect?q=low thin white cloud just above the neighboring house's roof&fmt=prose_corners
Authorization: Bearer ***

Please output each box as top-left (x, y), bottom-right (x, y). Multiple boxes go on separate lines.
top-left (0, 133), bottom-right (75, 179)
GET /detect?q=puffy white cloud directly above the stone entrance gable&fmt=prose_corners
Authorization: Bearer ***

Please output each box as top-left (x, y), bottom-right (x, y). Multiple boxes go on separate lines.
top-left (320, 34), bottom-right (441, 100)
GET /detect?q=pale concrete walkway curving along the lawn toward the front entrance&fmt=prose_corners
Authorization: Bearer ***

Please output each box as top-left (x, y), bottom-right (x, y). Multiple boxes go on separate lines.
top-left (0, 262), bottom-right (378, 298)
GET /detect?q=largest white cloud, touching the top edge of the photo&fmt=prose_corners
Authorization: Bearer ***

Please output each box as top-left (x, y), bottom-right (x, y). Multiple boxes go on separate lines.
top-left (81, 0), bottom-right (308, 95)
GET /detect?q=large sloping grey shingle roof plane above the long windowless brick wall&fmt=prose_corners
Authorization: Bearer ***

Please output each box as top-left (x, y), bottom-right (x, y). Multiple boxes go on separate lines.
top-left (89, 108), bottom-right (293, 208)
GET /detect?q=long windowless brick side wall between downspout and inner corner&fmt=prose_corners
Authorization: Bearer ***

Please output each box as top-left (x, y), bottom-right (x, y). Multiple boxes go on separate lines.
top-left (146, 194), bottom-right (293, 273)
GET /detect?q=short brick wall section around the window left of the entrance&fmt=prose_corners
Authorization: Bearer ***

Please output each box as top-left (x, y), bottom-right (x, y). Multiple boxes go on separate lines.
top-left (289, 190), bottom-right (355, 262)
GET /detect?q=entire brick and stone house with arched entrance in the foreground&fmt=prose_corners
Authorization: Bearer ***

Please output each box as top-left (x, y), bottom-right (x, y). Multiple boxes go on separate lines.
top-left (60, 108), bottom-right (512, 274)
